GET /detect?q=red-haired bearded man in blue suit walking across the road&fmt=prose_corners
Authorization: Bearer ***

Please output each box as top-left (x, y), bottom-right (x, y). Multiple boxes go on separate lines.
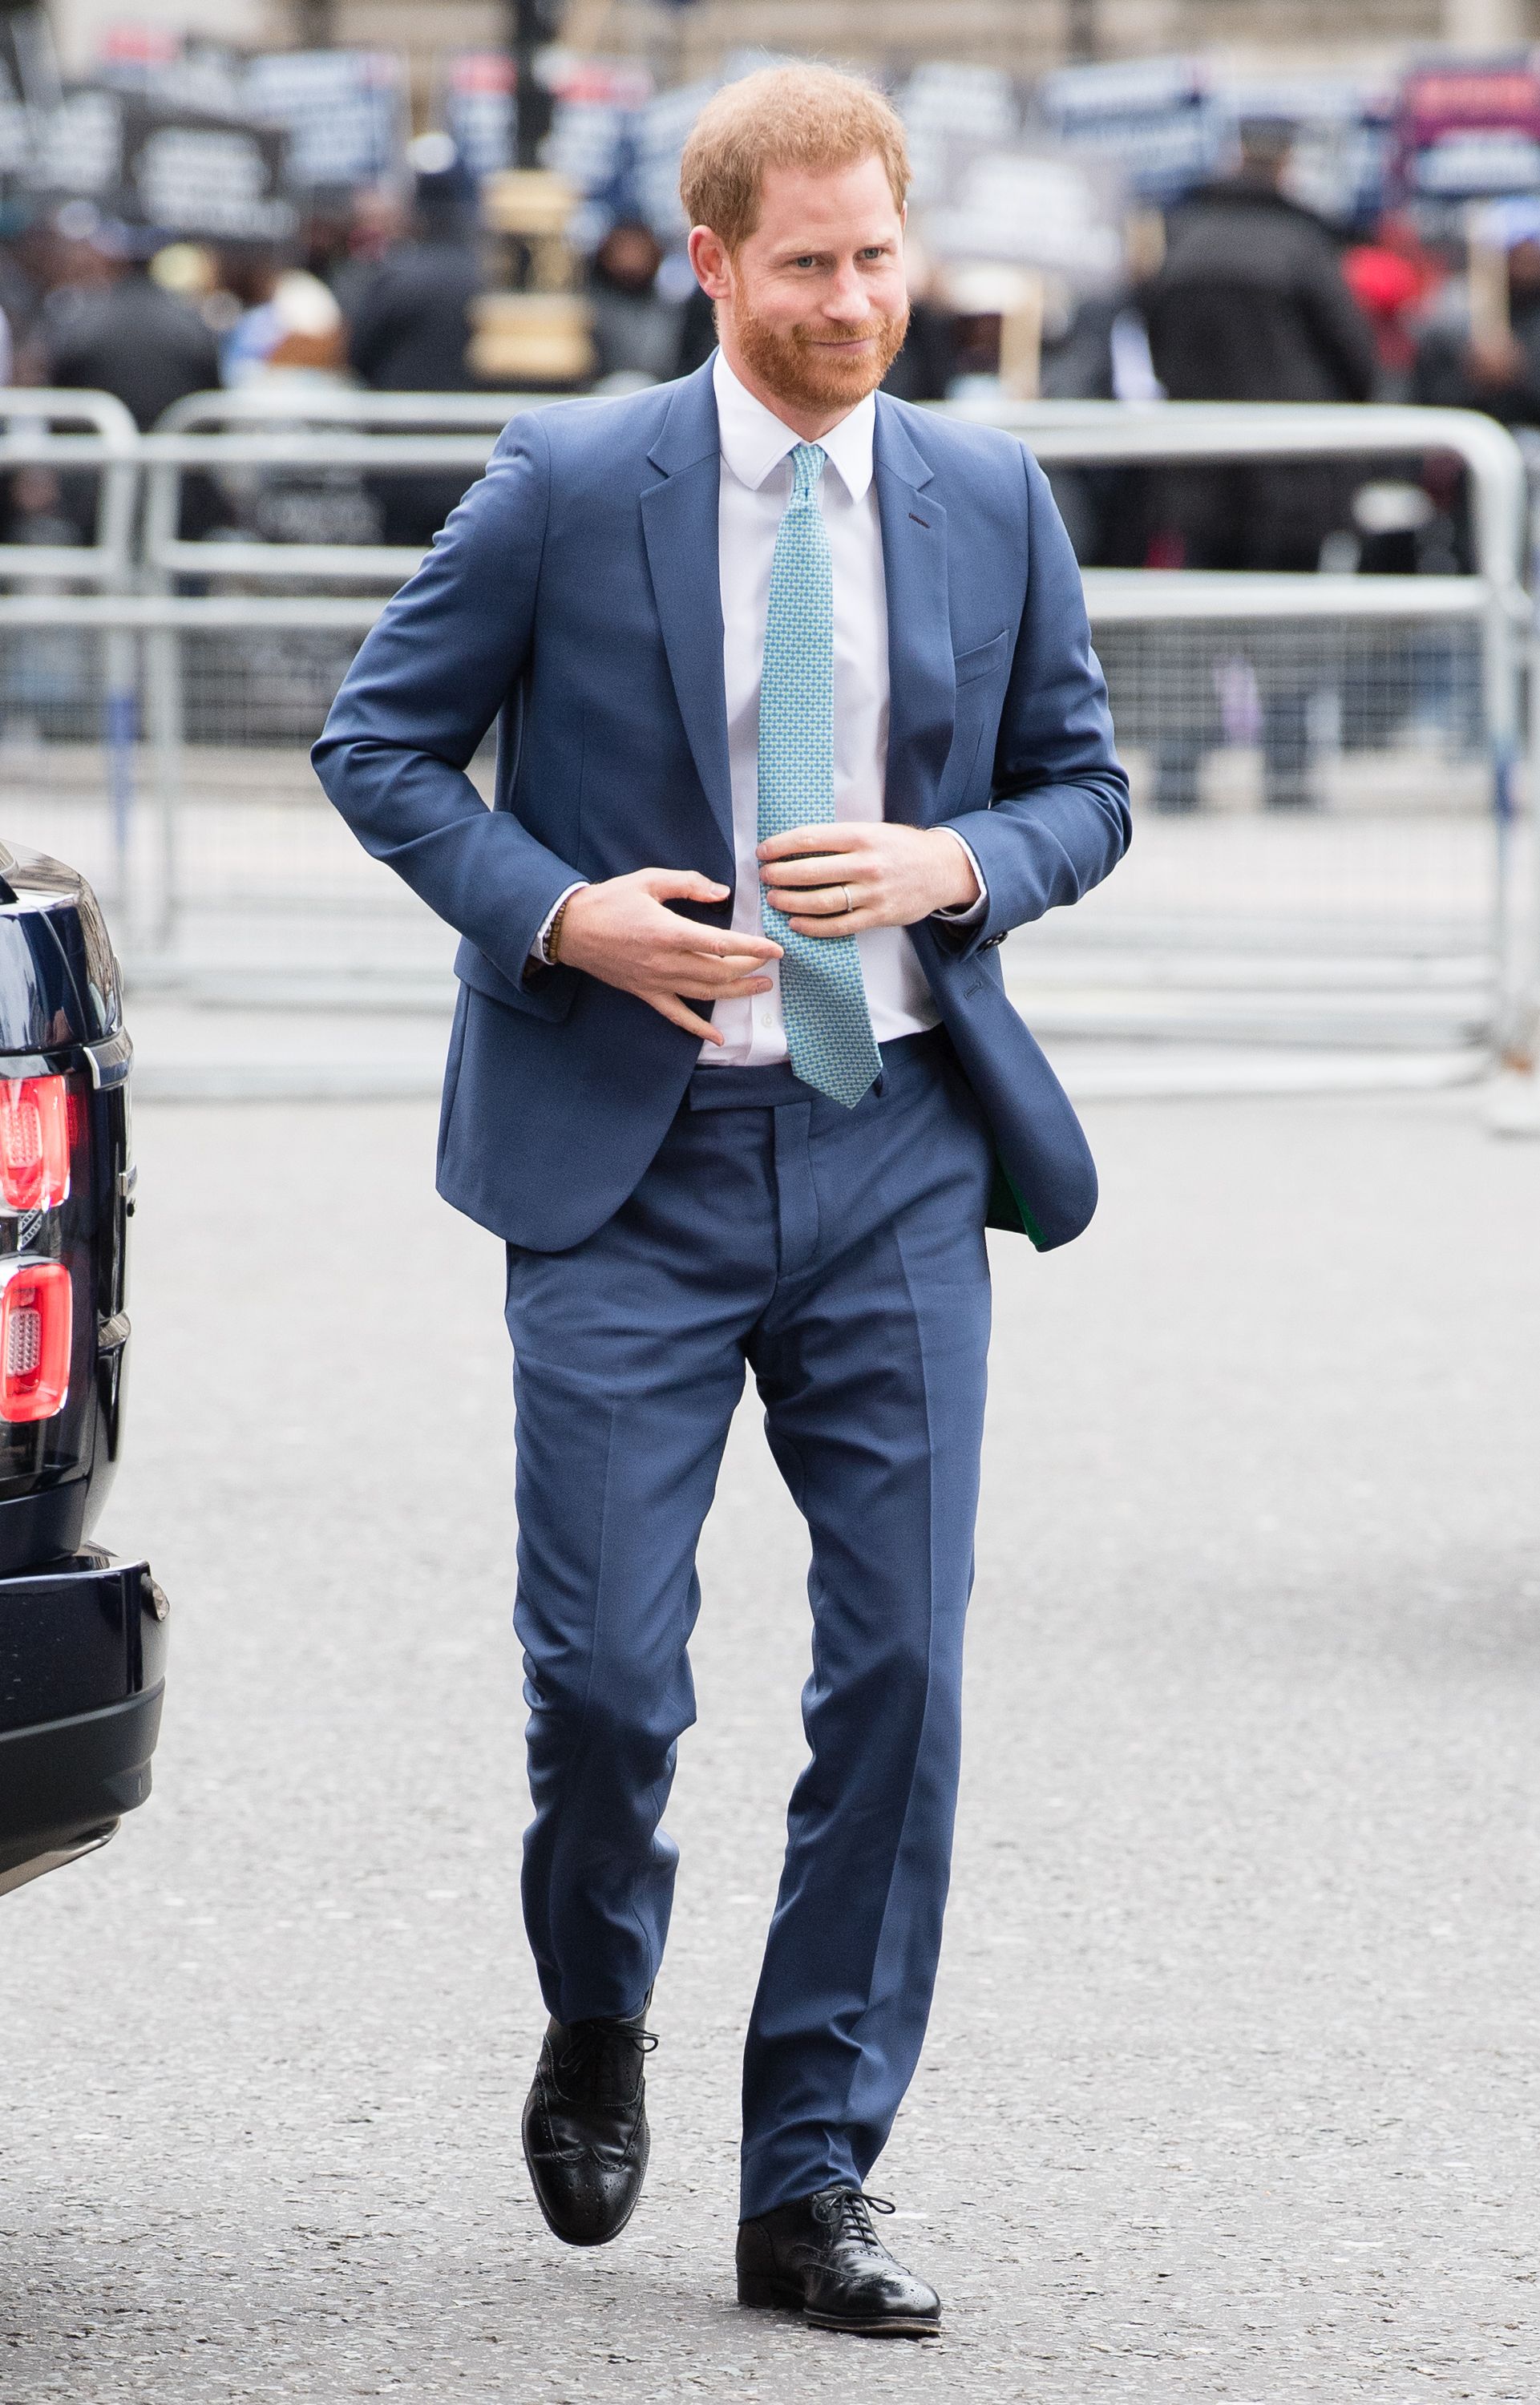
top-left (315, 67), bottom-right (1129, 2335)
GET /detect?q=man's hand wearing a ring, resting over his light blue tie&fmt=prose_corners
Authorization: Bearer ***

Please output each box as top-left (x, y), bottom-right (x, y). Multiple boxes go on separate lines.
top-left (758, 820), bottom-right (980, 936)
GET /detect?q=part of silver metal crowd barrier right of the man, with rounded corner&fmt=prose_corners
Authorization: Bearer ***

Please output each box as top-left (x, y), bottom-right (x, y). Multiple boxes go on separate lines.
top-left (986, 402), bottom-right (1540, 1073)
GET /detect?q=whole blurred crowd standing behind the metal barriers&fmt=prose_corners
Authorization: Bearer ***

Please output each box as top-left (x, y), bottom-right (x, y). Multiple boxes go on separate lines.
top-left (0, 101), bottom-right (1540, 810)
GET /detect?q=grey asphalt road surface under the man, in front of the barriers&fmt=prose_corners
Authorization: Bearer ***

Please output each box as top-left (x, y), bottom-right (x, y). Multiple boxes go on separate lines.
top-left (0, 1094), bottom-right (1540, 2405)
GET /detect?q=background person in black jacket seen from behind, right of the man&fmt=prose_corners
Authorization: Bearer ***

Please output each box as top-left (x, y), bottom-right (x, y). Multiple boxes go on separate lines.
top-left (1138, 123), bottom-right (1379, 810)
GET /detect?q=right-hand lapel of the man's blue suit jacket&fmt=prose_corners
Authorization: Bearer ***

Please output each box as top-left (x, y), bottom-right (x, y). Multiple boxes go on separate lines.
top-left (874, 392), bottom-right (958, 825)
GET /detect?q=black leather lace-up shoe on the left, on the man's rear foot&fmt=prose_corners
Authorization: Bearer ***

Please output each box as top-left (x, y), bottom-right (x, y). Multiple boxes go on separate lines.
top-left (524, 2013), bottom-right (657, 2246)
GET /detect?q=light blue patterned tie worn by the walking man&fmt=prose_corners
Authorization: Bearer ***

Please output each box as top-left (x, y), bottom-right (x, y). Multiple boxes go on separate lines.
top-left (760, 443), bottom-right (883, 1111)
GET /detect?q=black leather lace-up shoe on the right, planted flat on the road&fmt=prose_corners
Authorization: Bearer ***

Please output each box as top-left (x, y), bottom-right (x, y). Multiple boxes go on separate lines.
top-left (738, 2189), bottom-right (941, 2338)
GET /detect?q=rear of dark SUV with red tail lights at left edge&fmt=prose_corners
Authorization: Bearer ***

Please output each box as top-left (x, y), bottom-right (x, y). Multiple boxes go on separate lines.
top-left (0, 844), bottom-right (166, 1895)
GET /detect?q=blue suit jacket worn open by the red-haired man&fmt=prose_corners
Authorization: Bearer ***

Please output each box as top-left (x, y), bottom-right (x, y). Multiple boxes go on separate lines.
top-left (315, 363), bottom-right (1129, 1251)
